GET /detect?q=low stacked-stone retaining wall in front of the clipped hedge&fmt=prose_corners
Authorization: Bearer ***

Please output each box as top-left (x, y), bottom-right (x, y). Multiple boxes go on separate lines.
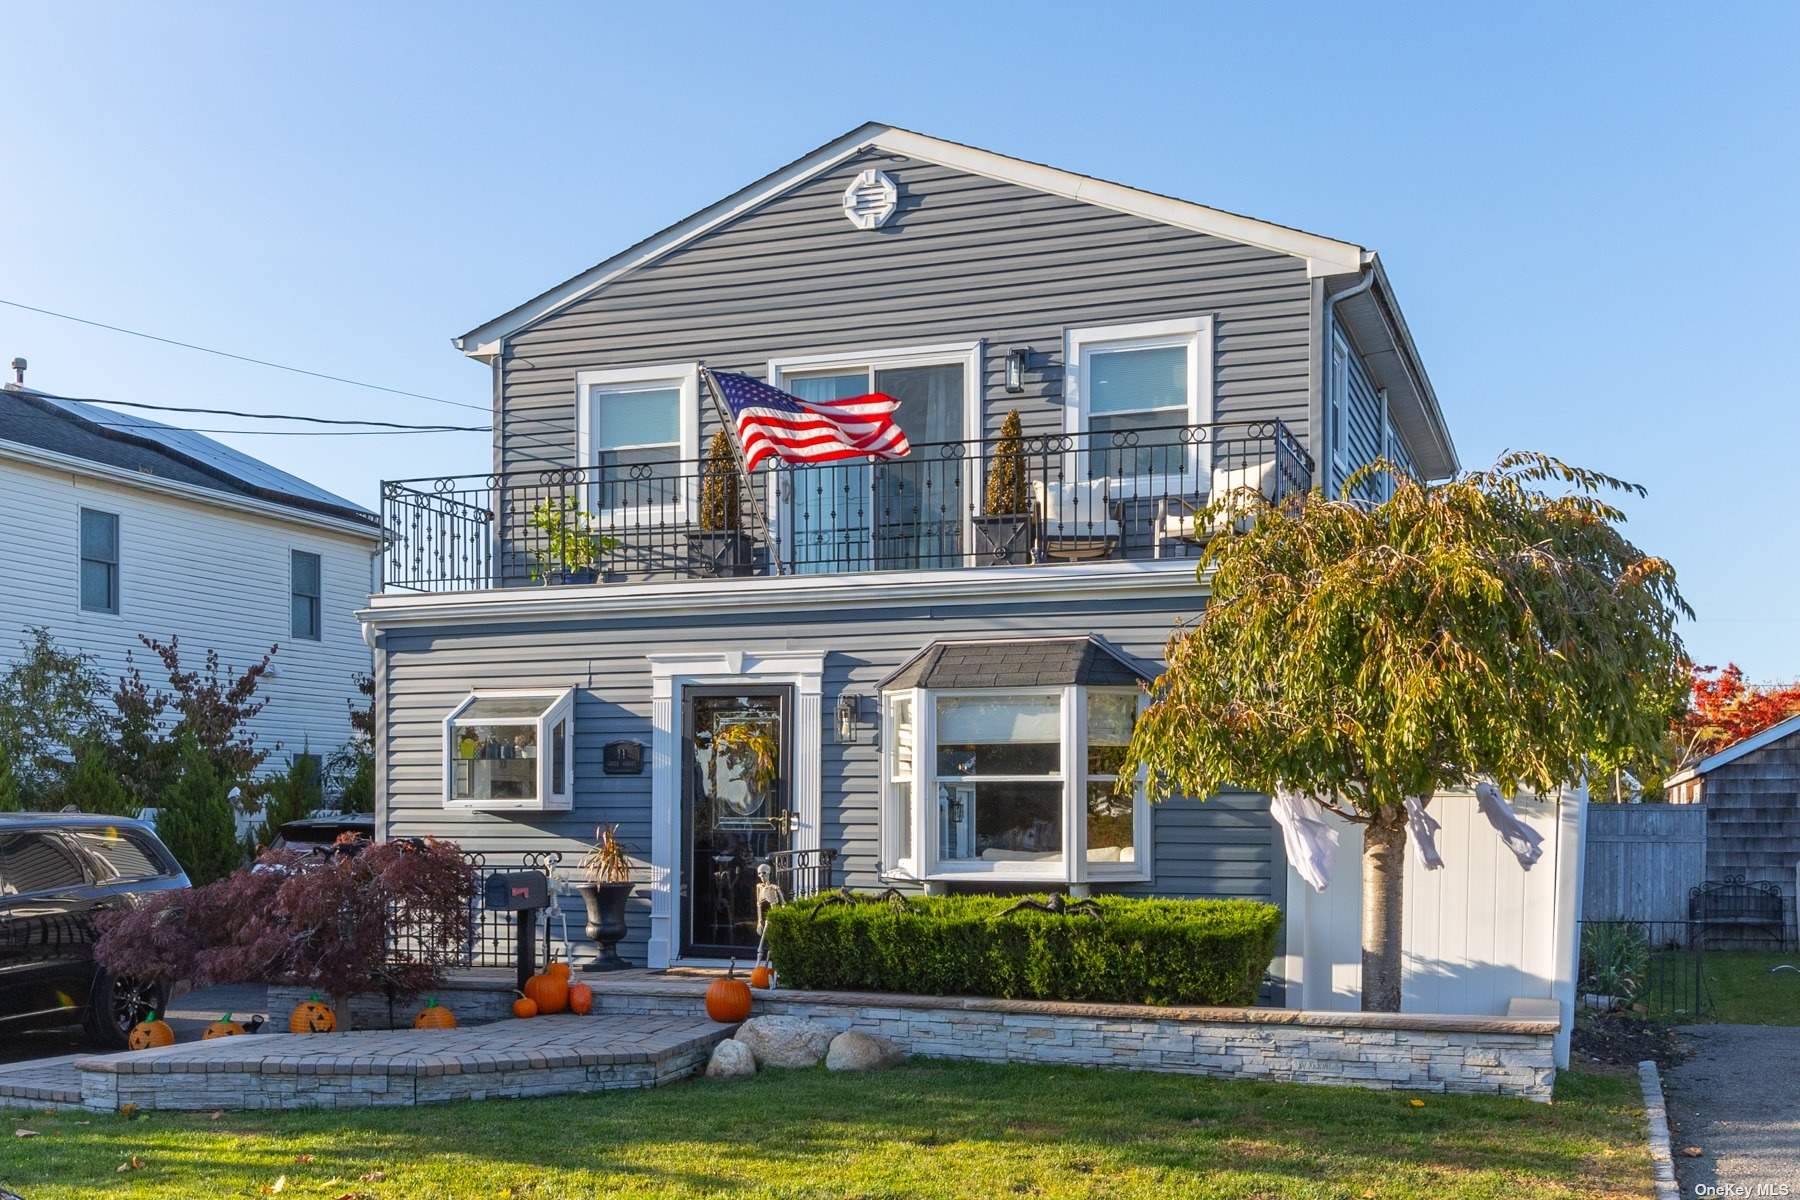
top-left (596, 981), bottom-right (1557, 1101)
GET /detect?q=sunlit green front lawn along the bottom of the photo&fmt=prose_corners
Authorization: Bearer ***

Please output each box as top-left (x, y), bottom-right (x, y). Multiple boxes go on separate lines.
top-left (0, 1061), bottom-right (1649, 1200)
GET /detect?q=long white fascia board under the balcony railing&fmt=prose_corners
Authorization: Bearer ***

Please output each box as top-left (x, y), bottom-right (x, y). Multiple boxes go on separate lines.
top-left (356, 560), bottom-right (1208, 631)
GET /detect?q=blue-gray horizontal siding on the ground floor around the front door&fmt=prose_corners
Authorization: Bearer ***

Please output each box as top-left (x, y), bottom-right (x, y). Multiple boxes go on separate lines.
top-left (378, 597), bottom-right (1285, 961)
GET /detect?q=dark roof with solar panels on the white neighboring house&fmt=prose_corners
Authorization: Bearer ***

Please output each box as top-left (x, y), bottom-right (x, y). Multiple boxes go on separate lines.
top-left (0, 385), bottom-right (378, 531)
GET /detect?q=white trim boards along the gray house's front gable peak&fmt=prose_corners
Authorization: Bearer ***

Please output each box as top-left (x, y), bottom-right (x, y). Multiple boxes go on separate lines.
top-left (455, 122), bottom-right (1370, 358)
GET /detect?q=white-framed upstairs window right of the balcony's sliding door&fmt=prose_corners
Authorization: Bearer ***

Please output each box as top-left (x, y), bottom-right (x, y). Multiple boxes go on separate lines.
top-left (1062, 317), bottom-right (1213, 491)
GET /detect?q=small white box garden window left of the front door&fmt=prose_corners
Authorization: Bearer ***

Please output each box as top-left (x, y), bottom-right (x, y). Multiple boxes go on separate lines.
top-left (443, 687), bottom-right (574, 810)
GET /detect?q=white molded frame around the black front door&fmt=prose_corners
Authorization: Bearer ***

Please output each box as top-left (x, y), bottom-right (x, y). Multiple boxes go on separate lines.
top-left (646, 649), bottom-right (824, 968)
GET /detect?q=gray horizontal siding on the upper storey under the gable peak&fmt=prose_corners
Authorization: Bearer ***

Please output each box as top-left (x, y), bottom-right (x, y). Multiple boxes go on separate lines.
top-left (497, 151), bottom-right (1312, 471)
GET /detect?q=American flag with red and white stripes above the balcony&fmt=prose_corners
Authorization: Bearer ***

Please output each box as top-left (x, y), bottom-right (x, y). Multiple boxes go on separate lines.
top-left (706, 371), bottom-right (913, 471)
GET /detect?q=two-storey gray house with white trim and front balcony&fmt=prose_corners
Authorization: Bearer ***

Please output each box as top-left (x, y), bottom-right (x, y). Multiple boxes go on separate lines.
top-left (362, 124), bottom-right (1458, 966)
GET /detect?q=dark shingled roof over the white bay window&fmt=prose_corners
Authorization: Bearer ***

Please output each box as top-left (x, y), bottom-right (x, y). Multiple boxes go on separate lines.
top-left (875, 633), bottom-right (1156, 691)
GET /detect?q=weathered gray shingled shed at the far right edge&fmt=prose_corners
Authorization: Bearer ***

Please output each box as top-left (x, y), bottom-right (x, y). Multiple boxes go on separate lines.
top-left (1667, 716), bottom-right (1800, 896)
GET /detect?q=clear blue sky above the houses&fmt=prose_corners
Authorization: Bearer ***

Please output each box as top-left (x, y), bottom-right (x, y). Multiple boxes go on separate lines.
top-left (0, 2), bottom-right (1800, 680)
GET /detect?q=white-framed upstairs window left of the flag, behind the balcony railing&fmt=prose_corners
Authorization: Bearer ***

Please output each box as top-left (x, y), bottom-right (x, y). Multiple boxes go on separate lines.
top-left (576, 363), bottom-right (700, 525)
